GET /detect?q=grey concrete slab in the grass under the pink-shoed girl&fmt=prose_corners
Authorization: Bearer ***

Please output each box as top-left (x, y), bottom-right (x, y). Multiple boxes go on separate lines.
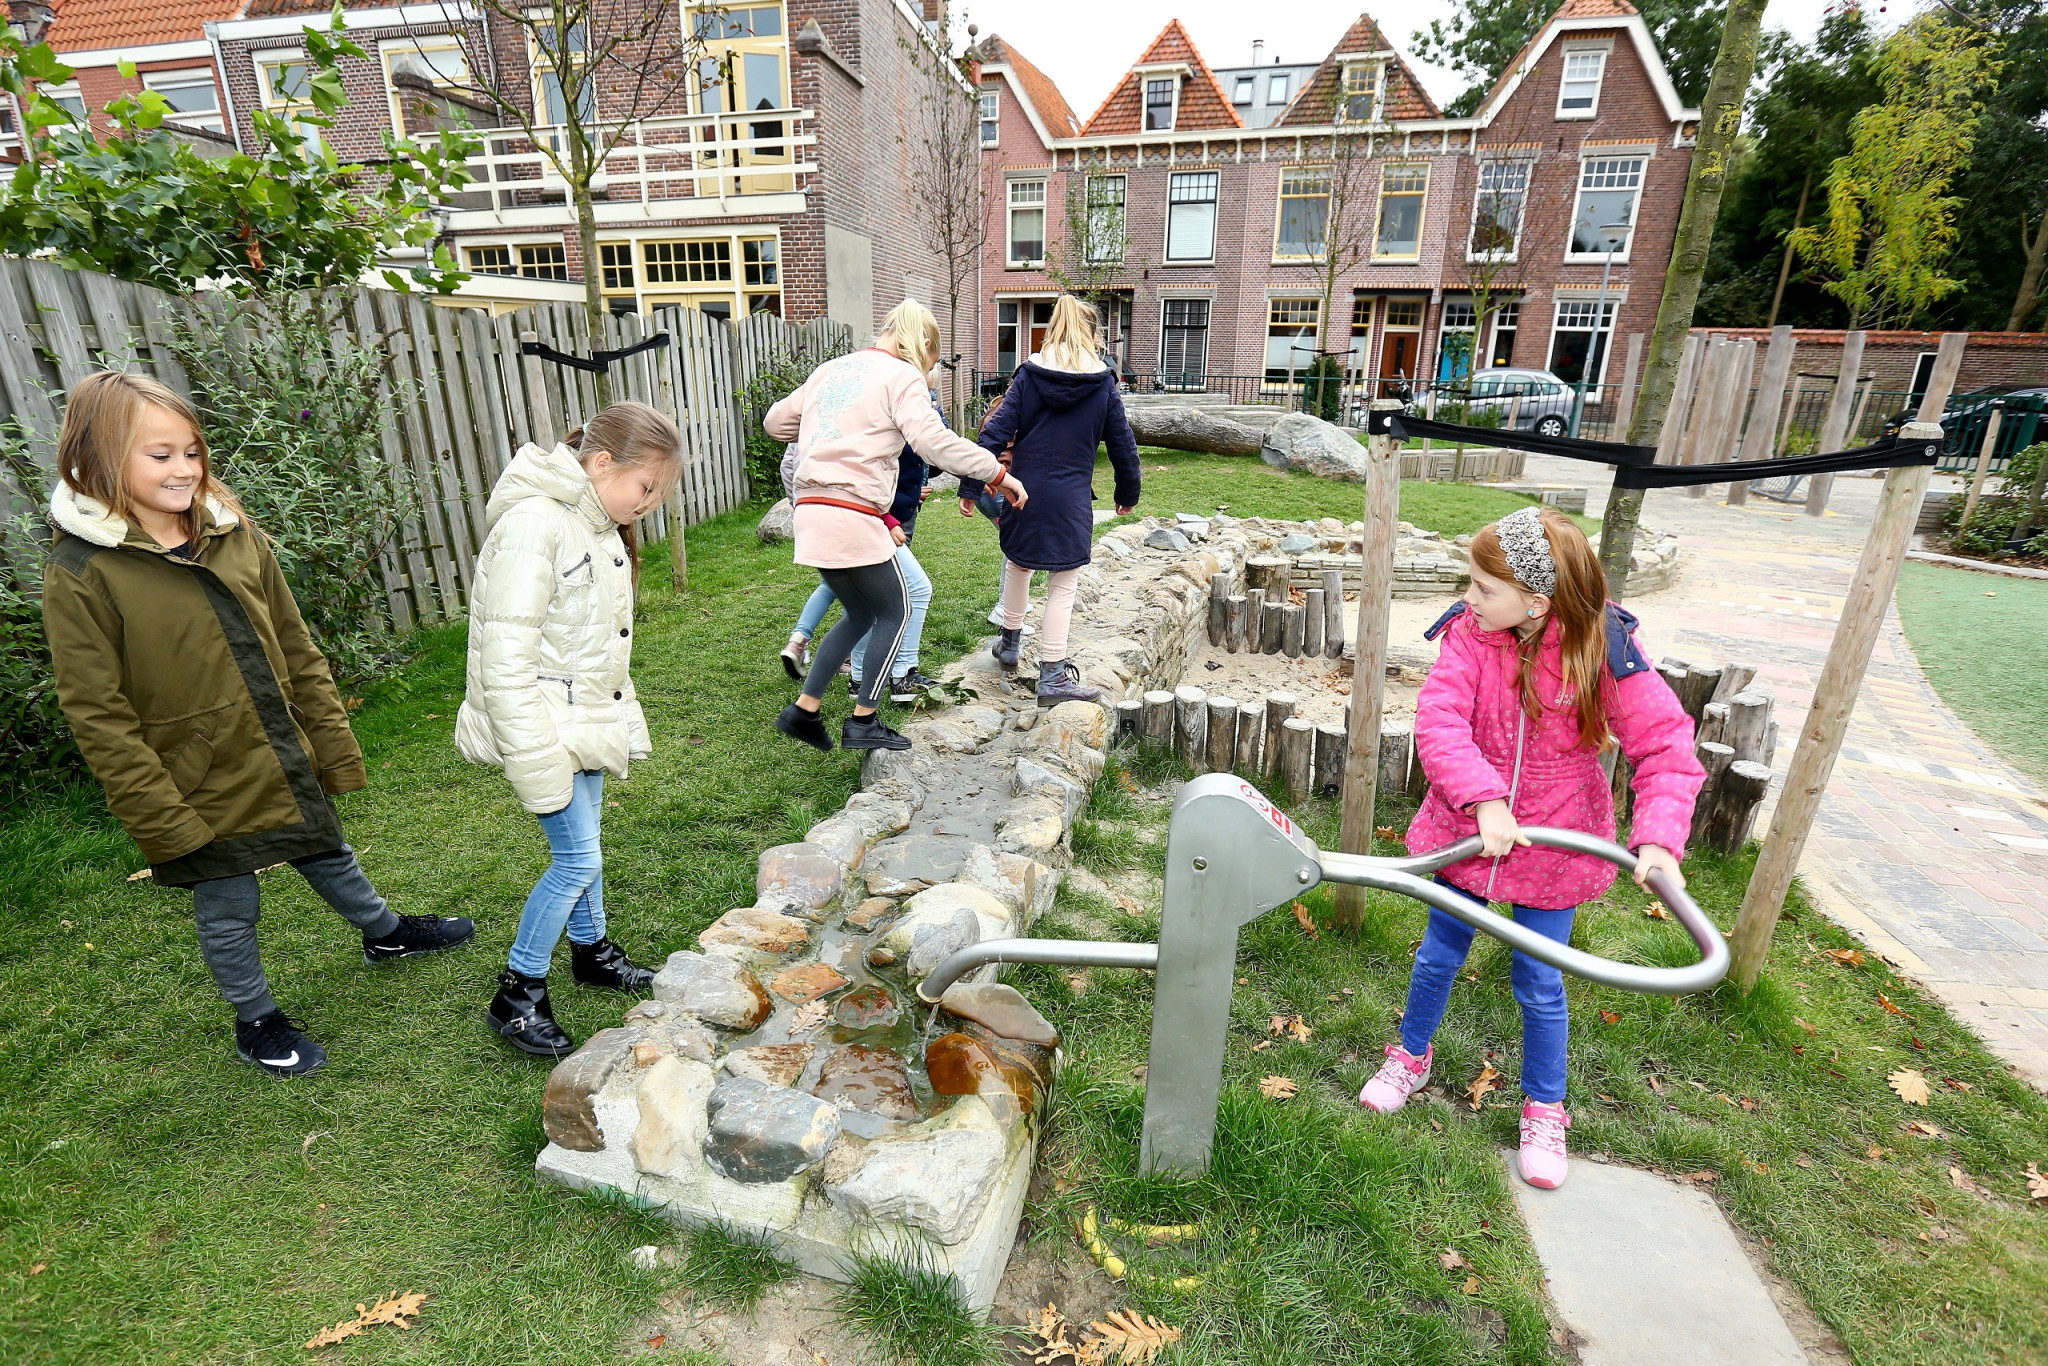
top-left (1503, 1153), bottom-right (1808, 1366)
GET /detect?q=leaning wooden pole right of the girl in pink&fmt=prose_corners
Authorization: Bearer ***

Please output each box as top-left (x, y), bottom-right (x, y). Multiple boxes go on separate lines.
top-left (1731, 332), bottom-right (1968, 991)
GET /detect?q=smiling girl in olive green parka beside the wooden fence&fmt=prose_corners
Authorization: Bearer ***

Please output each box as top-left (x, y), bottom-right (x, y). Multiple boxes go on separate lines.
top-left (43, 371), bottom-right (475, 1075)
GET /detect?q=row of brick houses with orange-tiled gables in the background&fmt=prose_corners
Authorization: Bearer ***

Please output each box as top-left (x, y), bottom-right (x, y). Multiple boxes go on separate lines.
top-left (981, 0), bottom-right (1698, 411)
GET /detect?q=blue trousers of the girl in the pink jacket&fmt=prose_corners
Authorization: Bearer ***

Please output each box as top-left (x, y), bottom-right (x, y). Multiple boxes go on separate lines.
top-left (1401, 879), bottom-right (1579, 1104)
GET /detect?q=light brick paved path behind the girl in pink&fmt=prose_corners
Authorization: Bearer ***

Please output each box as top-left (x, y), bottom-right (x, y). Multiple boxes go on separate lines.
top-left (1528, 455), bottom-right (2048, 1090)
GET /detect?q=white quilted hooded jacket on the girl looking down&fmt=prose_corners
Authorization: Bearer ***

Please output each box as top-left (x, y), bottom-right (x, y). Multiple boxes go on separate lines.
top-left (455, 446), bottom-right (653, 815)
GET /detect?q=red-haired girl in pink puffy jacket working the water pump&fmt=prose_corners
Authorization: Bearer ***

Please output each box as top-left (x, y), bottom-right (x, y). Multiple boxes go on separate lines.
top-left (1358, 508), bottom-right (1706, 1190)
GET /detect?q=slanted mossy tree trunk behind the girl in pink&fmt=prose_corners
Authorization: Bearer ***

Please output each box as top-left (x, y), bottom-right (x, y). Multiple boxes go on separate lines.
top-left (1599, 0), bottom-right (1763, 598)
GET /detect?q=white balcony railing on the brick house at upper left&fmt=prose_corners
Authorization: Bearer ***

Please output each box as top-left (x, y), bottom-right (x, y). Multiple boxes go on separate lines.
top-left (449, 109), bottom-right (817, 211)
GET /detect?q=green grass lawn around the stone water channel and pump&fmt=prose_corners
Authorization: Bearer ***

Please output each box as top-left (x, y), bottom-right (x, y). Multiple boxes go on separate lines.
top-left (0, 455), bottom-right (2048, 1366)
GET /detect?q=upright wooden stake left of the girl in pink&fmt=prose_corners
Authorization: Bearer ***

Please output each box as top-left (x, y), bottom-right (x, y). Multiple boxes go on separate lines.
top-left (1335, 399), bottom-right (1401, 930)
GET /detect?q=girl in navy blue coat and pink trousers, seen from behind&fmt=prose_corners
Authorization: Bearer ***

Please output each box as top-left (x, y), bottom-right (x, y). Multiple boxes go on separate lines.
top-left (961, 295), bottom-right (1139, 707)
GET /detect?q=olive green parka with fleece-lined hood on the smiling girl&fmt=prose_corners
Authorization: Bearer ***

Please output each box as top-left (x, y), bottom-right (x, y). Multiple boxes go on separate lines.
top-left (43, 483), bottom-right (369, 887)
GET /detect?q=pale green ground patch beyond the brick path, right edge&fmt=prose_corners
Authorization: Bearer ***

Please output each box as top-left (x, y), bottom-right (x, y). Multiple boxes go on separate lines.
top-left (1898, 563), bottom-right (2048, 782)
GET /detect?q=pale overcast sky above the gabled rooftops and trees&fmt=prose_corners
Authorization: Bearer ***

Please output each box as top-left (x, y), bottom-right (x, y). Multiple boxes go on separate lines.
top-left (952, 0), bottom-right (1917, 119)
